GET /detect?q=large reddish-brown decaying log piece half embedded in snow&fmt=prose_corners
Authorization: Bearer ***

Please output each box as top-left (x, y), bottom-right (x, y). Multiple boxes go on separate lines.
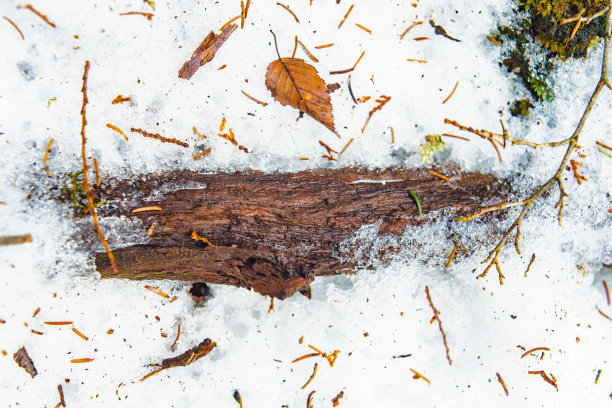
top-left (95, 167), bottom-right (507, 299)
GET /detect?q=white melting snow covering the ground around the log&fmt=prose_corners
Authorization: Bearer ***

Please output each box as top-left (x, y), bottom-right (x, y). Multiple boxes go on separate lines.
top-left (0, 0), bottom-right (612, 407)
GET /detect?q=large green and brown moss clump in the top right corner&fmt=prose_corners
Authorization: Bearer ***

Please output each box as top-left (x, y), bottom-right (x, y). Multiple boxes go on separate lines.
top-left (492, 0), bottom-right (607, 101)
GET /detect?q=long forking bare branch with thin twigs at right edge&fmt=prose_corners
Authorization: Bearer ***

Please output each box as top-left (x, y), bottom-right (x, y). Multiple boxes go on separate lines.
top-left (452, 0), bottom-right (612, 285)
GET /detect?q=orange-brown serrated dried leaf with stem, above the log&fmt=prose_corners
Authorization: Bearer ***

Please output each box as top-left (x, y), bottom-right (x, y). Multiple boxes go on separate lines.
top-left (266, 58), bottom-right (340, 137)
